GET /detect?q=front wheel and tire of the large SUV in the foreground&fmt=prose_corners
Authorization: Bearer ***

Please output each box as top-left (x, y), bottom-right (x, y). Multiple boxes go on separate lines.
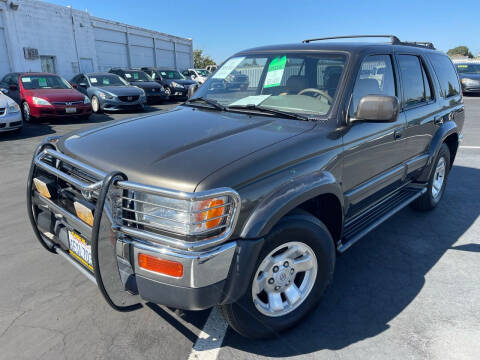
top-left (220, 213), bottom-right (335, 338)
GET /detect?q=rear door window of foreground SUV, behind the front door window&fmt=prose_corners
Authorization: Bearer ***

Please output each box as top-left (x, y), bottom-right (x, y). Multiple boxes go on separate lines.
top-left (398, 55), bottom-right (432, 107)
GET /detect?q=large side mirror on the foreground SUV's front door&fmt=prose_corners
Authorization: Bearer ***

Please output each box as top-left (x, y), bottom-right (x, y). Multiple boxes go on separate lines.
top-left (350, 95), bottom-right (400, 122)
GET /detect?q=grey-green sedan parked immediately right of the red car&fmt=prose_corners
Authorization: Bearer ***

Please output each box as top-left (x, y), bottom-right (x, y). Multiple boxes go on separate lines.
top-left (70, 73), bottom-right (147, 113)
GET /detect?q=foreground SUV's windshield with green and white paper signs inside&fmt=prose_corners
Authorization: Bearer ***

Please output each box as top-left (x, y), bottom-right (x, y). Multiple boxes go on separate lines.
top-left (193, 53), bottom-right (346, 115)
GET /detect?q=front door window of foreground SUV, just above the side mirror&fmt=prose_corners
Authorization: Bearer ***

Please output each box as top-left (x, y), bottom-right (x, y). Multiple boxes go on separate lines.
top-left (350, 55), bottom-right (396, 115)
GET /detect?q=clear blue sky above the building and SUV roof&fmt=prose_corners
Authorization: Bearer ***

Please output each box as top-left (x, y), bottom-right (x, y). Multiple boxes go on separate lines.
top-left (48, 0), bottom-right (480, 63)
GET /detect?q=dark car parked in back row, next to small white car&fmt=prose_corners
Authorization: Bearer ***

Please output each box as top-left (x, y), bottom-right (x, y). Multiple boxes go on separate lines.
top-left (142, 67), bottom-right (197, 99)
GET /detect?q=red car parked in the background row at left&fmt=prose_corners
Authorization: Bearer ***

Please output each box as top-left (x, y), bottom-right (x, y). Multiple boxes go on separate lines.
top-left (0, 73), bottom-right (92, 122)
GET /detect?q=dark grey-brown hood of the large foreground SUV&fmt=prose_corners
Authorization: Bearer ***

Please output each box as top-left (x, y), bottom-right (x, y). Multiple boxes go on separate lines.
top-left (58, 106), bottom-right (314, 192)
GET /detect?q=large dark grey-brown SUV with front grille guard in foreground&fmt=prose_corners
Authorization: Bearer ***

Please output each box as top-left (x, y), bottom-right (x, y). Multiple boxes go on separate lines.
top-left (27, 36), bottom-right (465, 338)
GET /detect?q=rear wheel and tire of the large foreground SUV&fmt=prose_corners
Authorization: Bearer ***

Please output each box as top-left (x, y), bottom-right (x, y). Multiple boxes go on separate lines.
top-left (412, 143), bottom-right (450, 211)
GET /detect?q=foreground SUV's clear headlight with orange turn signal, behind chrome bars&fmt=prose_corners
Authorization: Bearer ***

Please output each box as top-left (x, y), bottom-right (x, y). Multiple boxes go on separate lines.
top-left (123, 193), bottom-right (238, 236)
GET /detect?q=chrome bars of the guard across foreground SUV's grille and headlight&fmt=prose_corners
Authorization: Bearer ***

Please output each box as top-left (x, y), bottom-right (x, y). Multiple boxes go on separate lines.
top-left (30, 146), bottom-right (240, 251)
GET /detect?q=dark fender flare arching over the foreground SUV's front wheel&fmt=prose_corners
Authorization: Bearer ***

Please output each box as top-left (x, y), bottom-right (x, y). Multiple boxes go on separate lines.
top-left (240, 171), bottom-right (344, 239)
